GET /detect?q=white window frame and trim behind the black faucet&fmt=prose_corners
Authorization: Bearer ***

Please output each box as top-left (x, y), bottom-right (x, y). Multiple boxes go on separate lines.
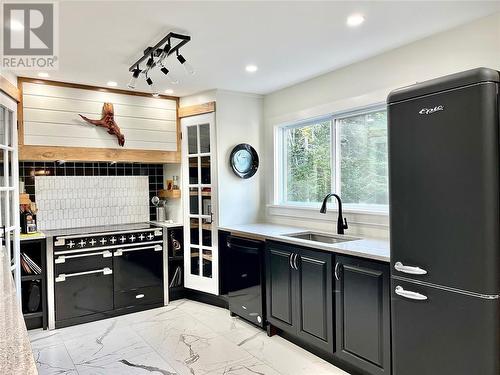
top-left (274, 103), bottom-right (389, 214)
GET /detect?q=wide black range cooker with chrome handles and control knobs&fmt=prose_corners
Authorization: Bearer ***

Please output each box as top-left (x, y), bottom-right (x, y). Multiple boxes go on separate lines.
top-left (47, 224), bottom-right (166, 328)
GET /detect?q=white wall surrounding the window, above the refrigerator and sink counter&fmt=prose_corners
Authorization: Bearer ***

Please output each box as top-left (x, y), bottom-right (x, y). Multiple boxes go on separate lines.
top-left (263, 14), bottom-right (500, 237)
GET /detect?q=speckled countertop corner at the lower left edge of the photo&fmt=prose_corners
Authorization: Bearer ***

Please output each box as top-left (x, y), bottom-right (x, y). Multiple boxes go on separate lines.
top-left (0, 248), bottom-right (37, 375)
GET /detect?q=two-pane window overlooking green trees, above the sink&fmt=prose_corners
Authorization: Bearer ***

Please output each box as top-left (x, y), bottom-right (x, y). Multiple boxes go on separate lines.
top-left (279, 108), bottom-right (389, 210)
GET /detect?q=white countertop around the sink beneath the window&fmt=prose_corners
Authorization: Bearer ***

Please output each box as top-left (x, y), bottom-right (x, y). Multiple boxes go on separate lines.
top-left (219, 223), bottom-right (391, 262)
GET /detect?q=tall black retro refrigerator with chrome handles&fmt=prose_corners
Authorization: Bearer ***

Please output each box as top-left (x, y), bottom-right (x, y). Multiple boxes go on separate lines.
top-left (388, 68), bottom-right (500, 375)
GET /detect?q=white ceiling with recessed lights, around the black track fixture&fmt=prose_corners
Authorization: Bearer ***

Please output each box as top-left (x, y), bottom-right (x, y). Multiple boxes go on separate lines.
top-left (9, 1), bottom-right (500, 96)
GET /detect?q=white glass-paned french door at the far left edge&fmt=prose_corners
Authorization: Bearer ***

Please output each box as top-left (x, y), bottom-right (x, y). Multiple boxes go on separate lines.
top-left (0, 93), bottom-right (21, 300)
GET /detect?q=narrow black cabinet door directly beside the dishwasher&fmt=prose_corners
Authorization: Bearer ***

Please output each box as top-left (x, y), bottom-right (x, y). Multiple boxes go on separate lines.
top-left (266, 244), bottom-right (295, 333)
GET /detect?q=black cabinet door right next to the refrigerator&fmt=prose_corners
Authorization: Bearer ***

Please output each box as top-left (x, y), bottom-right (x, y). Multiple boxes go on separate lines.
top-left (334, 256), bottom-right (391, 374)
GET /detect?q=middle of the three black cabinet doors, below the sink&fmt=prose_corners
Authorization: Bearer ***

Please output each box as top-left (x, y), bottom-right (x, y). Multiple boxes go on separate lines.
top-left (293, 249), bottom-right (334, 353)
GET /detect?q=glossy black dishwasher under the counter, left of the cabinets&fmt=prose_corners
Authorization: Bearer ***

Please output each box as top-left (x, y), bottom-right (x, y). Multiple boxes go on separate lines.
top-left (224, 235), bottom-right (266, 327)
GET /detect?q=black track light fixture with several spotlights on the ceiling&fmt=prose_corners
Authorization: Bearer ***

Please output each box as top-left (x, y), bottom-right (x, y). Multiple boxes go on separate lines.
top-left (128, 33), bottom-right (195, 91)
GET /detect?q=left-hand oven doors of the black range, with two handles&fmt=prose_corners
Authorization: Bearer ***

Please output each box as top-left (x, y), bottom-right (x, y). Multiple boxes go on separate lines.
top-left (54, 251), bottom-right (113, 321)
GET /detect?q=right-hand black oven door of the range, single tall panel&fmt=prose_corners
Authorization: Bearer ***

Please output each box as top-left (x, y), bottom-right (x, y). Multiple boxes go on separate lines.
top-left (113, 244), bottom-right (163, 308)
